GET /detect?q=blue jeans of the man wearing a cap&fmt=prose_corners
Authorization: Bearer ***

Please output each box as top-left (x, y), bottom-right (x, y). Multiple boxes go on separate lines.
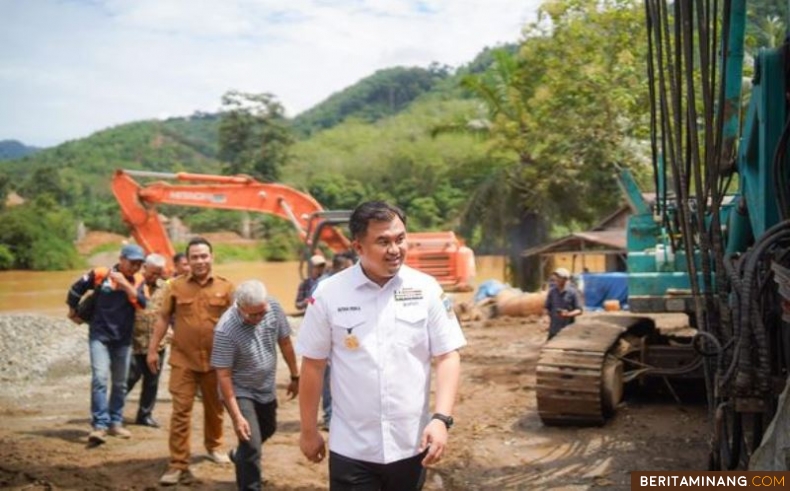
top-left (89, 339), bottom-right (132, 429)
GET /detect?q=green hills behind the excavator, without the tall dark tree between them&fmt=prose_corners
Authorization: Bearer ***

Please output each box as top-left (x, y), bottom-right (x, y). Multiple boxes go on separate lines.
top-left (0, 42), bottom-right (516, 250)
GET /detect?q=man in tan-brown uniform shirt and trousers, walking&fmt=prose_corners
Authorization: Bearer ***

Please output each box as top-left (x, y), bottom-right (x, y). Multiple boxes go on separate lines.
top-left (148, 237), bottom-right (233, 485)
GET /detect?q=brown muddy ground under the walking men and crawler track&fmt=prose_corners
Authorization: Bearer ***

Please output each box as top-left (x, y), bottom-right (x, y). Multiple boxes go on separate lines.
top-left (0, 318), bottom-right (707, 491)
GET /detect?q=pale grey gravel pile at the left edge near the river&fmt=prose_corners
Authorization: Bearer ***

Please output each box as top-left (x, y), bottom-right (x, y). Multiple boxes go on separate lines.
top-left (0, 314), bottom-right (90, 387)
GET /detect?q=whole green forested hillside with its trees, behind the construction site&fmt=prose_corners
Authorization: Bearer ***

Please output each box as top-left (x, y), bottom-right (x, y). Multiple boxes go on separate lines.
top-left (0, 0), bottom-right (775, 283)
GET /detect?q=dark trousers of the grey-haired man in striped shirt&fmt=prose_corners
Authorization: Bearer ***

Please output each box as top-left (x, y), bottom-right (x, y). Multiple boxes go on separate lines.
top-left (233, 397), bottom-right (277, 491)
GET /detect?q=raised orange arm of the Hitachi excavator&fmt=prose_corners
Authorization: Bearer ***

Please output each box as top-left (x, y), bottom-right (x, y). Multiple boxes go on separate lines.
top-left (112, 170), bottom-right (350, 259)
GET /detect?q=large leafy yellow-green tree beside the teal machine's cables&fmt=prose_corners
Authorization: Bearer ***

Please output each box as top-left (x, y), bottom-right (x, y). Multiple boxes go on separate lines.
top-left (463, 0), bottom-right (648, 288)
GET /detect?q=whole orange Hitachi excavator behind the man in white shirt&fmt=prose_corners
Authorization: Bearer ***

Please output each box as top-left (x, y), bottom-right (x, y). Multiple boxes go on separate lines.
top-left (112, 170), bottom-right (475, 291)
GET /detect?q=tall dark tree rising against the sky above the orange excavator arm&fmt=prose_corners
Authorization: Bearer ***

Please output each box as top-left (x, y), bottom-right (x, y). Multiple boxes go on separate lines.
top-left (219, 91), bottom-right (294, 182)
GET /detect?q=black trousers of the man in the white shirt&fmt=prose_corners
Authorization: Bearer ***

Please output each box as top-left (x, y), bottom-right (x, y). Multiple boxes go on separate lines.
top-left (329, 450), bottom-right (427, 491)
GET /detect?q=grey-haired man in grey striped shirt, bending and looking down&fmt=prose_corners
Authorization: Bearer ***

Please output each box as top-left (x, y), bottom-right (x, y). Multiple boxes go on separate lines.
top-left (211, 280), bottom-right (299, 490)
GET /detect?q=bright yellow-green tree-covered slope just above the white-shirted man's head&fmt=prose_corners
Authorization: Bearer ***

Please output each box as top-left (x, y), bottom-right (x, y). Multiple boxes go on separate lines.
top-left (284, 98), bottom-right (498, 236)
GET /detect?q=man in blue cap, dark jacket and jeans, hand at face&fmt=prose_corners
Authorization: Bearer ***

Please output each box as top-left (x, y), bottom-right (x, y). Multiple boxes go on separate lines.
top-left (66, 244), bottom-right (145, 446)
